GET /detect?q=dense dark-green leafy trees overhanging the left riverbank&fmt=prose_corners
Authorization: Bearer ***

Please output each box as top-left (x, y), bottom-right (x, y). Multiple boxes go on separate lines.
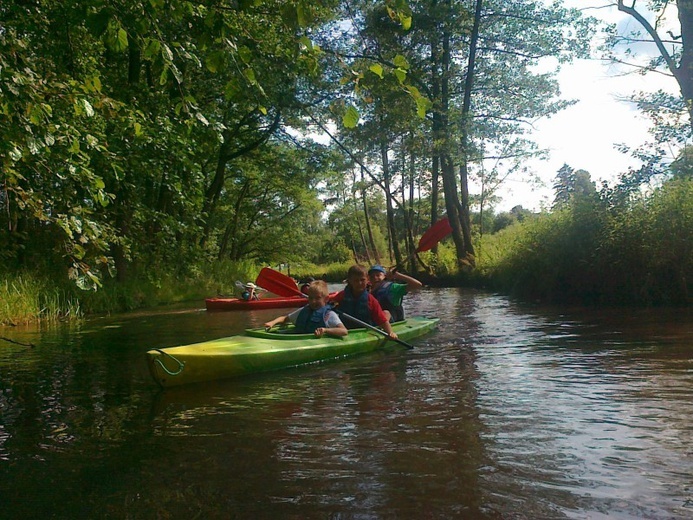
top-left (0, 0), bottom-right (346, 288)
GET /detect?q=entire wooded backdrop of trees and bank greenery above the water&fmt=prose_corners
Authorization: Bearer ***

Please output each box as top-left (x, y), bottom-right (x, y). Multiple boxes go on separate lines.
top-left (0, 0), bottom-right (693, 323)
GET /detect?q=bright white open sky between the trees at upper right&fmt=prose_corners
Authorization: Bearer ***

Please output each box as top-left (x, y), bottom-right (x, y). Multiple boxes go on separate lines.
top-left (495, 0), bottom-right (677, 212)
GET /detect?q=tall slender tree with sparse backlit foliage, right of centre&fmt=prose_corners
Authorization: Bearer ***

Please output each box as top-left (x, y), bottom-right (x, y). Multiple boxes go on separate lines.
top-left (323, 0), bottom-right (591, 268)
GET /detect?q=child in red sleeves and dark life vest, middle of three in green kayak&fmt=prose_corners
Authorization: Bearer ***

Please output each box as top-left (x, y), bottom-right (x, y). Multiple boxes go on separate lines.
top-left (332, 265), bottom-right (397, 339)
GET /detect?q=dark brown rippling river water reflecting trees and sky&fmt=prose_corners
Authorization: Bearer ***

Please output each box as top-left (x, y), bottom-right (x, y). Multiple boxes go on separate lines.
top-left (0, 288), bottom-right (693, 519)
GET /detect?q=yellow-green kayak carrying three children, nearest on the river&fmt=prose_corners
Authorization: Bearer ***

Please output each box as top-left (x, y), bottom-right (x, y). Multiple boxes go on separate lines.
top-left (147, 317), bottom-right (438, 387)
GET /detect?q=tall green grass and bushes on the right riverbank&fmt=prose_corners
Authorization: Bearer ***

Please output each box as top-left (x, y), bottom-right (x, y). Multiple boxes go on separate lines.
top-left (479, 180), bottom-right (693, 305)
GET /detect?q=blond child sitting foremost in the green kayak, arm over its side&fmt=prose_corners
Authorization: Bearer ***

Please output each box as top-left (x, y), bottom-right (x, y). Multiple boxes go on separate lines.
top-left (265, 280), bottom-right (349, 338)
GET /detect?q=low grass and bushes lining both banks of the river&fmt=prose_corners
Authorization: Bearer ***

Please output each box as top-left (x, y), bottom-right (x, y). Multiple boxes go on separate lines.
top-left (0, 179), bottom-right (693, 325)
